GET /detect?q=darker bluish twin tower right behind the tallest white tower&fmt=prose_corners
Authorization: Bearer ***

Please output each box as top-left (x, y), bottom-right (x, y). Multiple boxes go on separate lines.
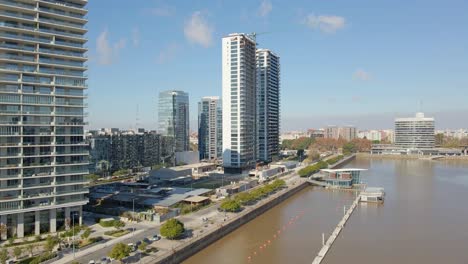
top-left (256, 49), bottom-right (280, 162)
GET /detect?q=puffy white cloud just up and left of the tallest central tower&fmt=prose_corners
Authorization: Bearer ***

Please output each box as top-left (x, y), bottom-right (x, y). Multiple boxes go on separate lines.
top-left (184, 11), bottom-right (213, 48)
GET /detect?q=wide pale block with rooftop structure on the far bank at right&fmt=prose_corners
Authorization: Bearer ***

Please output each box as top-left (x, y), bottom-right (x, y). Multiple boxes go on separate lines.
top-left (395, 113), bottom-right (435, 149)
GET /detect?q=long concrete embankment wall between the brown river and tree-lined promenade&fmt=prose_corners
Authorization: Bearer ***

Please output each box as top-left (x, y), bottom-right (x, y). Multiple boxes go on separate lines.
top-left (151, 181), bottom-right (308, 264)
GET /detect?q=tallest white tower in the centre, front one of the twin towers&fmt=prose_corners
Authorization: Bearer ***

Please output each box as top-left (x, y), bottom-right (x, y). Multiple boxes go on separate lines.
top-left (222, 33), bottom-right (256, 173)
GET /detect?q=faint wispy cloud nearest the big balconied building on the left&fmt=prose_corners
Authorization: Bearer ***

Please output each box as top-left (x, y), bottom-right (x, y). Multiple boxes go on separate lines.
top-left (96, 29), bottom-right (126, 65)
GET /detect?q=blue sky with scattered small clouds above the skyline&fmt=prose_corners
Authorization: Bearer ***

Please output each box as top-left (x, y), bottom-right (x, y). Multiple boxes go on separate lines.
top-left (87, 0), bottom-right (468, 131)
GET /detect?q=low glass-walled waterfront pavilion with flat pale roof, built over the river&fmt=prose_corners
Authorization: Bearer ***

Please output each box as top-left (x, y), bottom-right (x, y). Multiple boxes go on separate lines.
top-left (320, 168), bottom-right (366, 188)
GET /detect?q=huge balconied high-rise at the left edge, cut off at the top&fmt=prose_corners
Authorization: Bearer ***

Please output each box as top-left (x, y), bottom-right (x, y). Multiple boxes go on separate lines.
top-left (0, 0), bottom-right (89, 239)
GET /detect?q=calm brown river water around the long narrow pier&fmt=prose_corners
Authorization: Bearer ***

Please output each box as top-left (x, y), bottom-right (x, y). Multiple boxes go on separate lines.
top-left (184, 158), bottom-right (468, 264)
